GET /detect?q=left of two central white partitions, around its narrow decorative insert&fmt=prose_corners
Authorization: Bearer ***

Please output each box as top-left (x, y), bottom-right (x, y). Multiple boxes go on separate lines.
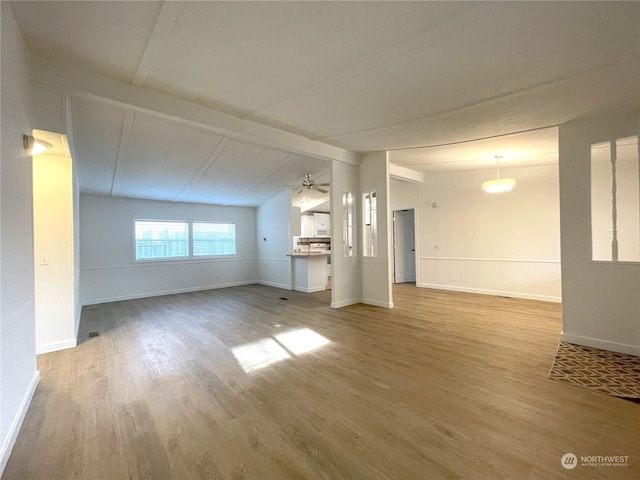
top-left (331, 160), bottom-right (362, 308)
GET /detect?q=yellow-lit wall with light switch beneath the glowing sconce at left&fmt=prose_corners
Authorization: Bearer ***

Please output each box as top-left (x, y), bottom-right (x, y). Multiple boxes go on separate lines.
top-left (33, 148), bottom-right (76, 354)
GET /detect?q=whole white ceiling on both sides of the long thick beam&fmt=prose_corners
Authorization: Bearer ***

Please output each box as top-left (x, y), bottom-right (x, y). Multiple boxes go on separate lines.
top-left (13, 1), bottom-right (640, 205)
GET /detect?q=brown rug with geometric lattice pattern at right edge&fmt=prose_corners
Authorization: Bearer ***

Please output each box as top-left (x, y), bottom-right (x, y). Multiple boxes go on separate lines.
top-left (549, 342), bottom-right (640, 398)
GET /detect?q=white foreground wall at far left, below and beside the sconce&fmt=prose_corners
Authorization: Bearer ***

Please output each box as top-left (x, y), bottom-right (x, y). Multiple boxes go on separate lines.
top-left (0, 2), bottom-right (39, 474)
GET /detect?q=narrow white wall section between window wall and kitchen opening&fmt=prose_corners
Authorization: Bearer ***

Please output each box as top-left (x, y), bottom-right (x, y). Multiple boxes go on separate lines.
top-left (256, 190), bottom-right (292, 289)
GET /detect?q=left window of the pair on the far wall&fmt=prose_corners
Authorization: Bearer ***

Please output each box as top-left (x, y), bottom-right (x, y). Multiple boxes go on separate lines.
top-left (135, 220), bottom-right (189, 260)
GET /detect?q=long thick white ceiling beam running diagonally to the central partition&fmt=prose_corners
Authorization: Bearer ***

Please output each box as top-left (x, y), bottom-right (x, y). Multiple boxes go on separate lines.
top-left (31, 55), bottom-right (360, 165)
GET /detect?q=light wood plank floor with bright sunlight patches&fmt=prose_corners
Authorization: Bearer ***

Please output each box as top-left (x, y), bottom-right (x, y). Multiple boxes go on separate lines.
top-left (2, 285), bottom-right (640, 480)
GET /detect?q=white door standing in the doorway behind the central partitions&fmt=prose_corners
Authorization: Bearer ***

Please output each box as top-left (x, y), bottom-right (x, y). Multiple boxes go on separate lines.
top-left (393, 209), bottom-right (416, 283)
